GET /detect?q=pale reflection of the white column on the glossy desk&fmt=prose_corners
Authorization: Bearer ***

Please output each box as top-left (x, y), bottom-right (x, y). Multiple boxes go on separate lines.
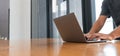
top-left (9, 40), bottom-right (31, 56)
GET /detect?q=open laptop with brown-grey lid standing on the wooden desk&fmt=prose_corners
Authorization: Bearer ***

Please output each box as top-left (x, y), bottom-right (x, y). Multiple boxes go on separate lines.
top-left (54, 13), bottom-right (105, 42)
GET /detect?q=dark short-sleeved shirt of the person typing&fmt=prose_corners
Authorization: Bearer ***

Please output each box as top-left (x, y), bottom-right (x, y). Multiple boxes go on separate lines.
top-left (101, 0), bottom-right (120, 26)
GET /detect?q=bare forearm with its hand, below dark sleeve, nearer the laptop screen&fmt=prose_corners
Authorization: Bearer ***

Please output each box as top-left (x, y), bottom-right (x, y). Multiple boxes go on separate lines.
top-left (84, 15), bottom-right (107, 40)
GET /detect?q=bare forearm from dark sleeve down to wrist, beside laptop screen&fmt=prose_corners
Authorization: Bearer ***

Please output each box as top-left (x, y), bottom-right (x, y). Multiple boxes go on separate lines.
top-left (89, 15), bottom-right (107, 33)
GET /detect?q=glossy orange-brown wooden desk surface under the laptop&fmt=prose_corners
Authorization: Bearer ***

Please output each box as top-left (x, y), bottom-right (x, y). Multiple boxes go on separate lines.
top-left (0, 39), bottom-right (120, 56)
